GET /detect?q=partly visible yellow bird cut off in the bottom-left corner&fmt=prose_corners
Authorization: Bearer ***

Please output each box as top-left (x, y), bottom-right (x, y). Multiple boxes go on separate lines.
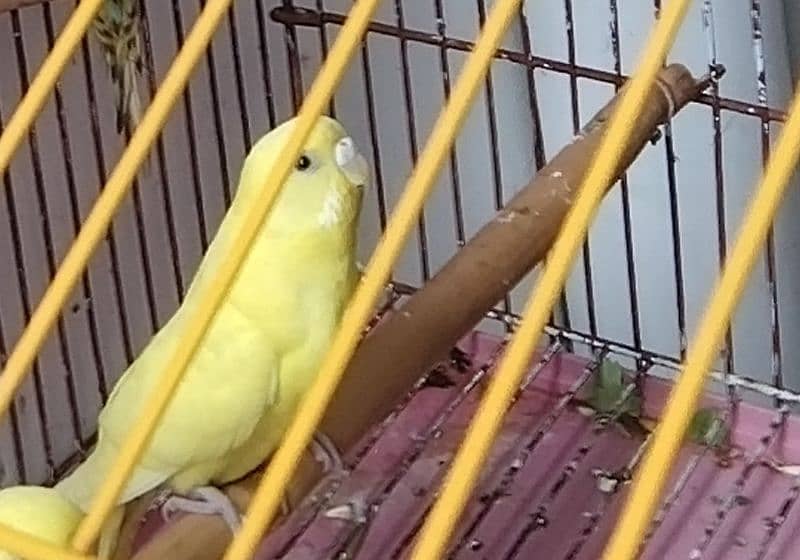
top-left (0, 486), bottom-right (83, 560)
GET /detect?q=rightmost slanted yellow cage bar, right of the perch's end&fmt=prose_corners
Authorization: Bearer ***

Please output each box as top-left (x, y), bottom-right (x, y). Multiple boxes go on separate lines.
top-left (604, 68), bottom-right (800, 560)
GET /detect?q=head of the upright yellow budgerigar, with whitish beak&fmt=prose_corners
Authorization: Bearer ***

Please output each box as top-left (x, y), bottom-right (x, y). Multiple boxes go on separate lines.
top-left (237, 116), bottom-right (369, 233)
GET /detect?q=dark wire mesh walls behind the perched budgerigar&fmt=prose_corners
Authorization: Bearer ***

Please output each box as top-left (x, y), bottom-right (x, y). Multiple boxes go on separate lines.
top-left (0, 0), bottom-right (800, 548)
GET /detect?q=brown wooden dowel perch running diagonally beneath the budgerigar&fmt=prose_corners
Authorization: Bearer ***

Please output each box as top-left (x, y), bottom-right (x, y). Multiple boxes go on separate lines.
top-left (119, 64), bottom-right (708, 560)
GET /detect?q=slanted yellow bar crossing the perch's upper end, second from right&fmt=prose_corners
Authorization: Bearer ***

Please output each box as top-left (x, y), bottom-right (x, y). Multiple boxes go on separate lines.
top-left (412, 0), bottom-right (689, 560)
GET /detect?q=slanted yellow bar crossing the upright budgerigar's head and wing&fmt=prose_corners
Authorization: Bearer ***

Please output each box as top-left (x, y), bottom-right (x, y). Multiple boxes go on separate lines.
top-left (73, 0), bottom-right (377, 550)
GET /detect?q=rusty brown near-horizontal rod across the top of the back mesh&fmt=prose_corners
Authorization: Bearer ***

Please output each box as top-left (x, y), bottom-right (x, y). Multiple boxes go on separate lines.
top-left (272, 8), bottom-right (786, 122)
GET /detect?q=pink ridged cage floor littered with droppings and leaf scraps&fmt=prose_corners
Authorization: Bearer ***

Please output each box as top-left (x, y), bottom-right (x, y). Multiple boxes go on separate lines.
top-left (133, 333), bottom-right (800, 560)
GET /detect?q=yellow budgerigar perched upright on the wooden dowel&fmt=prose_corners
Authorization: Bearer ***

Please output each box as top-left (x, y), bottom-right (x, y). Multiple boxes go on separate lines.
top-left (56, 117), bottom-right (368, 558)
